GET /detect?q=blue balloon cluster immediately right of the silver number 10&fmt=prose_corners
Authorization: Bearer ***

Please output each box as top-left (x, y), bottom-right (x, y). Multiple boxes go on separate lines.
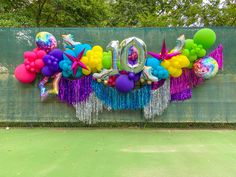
top-left (146, 58), bottom-right (169, 80)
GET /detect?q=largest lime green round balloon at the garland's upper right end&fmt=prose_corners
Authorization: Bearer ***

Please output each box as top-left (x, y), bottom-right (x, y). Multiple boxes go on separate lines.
top-left (193, 28), bottom-right (216, 49)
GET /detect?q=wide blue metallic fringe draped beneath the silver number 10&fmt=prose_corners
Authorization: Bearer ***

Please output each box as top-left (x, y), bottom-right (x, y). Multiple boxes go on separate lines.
top-left (92, 81), bottom-right (151, 110)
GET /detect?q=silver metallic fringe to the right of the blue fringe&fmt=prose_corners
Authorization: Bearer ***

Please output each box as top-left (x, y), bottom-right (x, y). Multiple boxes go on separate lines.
top-left (144, 79), bottom-right (170, 120)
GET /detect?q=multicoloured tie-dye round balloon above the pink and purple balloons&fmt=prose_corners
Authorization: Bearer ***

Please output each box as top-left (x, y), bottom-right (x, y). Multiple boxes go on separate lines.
top-left (35, 32), bottom-right (57, 52)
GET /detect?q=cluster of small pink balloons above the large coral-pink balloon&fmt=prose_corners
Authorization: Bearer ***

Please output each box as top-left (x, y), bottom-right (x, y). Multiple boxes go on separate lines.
top-left (24, 48), bottom-right (46, 73)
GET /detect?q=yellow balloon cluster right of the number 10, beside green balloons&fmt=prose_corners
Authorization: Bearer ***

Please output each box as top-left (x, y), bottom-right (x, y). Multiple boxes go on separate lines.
top-left (161, 55), bottom-right (190, 77)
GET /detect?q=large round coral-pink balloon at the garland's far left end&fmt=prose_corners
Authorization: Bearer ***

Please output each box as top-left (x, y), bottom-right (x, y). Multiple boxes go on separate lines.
top-left (14, 64), bottom-right (36, 84)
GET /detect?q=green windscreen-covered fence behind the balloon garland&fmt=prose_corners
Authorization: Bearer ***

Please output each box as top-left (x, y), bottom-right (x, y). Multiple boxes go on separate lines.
top-left (0, 28), bottom-right (236, 122)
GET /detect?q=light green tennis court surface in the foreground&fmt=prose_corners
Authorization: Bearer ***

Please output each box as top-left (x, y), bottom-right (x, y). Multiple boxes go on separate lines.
top-left (0, 128), bottom-right (236, 177)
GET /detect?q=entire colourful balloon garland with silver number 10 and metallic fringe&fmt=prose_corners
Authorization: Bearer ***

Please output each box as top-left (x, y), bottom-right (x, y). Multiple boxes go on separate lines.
top-left (15, 28), bottom-right (223, 123)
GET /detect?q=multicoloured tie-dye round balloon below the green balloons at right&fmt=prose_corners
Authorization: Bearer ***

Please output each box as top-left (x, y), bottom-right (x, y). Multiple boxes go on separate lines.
top-left (193, 57), bottom-right (219, 79)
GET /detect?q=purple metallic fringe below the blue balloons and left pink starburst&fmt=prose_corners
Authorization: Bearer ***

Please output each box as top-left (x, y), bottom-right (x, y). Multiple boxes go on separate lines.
top-left (58, 76), bottom-right (92, 104)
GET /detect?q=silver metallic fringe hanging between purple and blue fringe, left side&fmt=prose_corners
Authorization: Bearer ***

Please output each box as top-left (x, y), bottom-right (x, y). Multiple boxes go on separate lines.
top-left (73, 93), bottom-right (103, 124)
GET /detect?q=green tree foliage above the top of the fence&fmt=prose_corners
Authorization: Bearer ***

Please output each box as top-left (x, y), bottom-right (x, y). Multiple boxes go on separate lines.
top-left (0, 0), bottom-right (236, 27)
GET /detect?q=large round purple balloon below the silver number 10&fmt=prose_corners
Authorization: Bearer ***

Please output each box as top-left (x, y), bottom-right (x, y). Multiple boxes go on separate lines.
top-left (116, 74), bottom-right (134, 93)
